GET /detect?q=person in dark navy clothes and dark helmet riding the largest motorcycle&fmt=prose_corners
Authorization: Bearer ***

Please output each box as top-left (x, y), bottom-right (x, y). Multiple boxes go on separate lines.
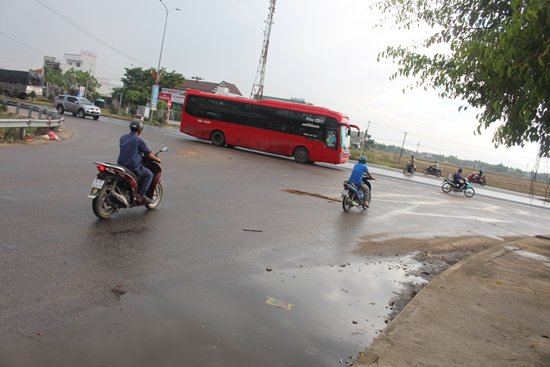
top-left (117, 120), bottom-right (162, 201)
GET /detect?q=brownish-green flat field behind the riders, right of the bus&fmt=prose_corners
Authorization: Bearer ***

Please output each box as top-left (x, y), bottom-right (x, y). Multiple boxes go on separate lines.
top-left (352, 151), bottom-right (550, 197)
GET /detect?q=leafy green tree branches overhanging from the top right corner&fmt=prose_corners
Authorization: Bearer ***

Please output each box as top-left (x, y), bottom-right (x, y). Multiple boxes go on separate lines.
top-left (373, 0), bottom-right (550, 157)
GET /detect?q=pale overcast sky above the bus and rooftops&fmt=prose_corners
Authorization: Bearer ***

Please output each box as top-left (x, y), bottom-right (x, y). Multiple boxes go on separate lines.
top-left (0, 0), bottom-right (548, 170)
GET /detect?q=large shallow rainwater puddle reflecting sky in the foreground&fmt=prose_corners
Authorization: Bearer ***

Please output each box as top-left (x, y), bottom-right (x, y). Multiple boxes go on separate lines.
top-left (10, 261), bottom-right (430, 367)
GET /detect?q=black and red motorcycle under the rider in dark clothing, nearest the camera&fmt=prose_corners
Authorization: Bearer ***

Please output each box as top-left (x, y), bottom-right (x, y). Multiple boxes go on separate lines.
top-left (88, 147), bottom-right (168, 219)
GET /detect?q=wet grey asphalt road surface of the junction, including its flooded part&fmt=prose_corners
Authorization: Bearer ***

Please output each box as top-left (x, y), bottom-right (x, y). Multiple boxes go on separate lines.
top-left (0, 116), bottom-right (549, 366)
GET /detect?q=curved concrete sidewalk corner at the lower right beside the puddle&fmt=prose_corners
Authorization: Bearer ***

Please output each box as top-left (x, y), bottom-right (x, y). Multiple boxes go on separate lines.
top-left (357, 236), bottom-right (550, 367)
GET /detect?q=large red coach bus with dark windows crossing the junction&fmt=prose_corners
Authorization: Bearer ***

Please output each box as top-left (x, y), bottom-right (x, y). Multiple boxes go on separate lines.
top-left (180, 89), bottom-right (359, 164)
